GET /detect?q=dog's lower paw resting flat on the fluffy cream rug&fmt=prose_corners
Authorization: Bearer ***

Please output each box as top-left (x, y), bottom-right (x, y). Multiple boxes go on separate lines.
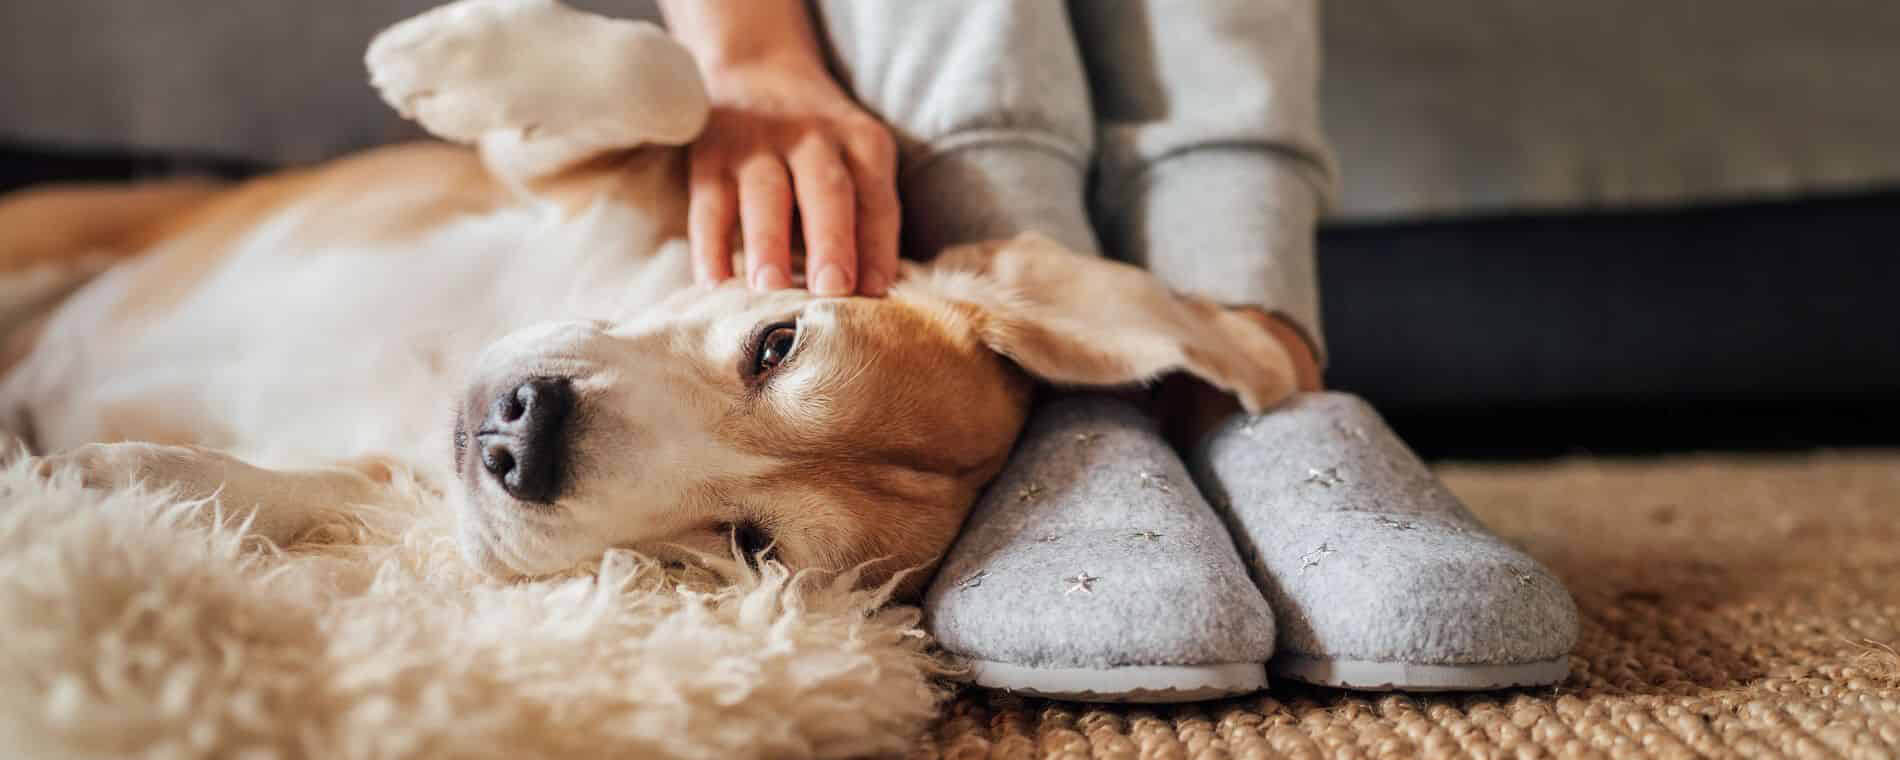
top-left (34, 443), bottom-right (243, 498)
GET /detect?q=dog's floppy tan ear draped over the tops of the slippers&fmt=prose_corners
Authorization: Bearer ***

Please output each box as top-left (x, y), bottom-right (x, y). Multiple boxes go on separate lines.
top-left (918, 234), bottom-right (1296, 412)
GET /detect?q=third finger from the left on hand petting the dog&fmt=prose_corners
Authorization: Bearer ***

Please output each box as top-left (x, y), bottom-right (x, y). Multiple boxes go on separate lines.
top-left (790, 139), bottom-right (859, 296)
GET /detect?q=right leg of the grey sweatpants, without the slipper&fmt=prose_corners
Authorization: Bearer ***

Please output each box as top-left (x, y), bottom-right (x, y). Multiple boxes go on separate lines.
top-left (1072, 0), bottom-right (1336, 362)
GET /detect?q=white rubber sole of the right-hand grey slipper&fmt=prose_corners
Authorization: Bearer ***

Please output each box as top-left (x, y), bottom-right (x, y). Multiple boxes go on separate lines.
top-left (1267, 654), bottom-right (1569, 692)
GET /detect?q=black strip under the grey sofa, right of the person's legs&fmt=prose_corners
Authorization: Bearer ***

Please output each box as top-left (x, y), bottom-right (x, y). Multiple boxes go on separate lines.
top-left (1321, 190), bottom-right (1900, 454)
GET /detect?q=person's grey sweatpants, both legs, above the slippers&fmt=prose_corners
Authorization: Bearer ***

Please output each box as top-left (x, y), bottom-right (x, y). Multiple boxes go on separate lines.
top-left (815, 0), bottom-right (1336, 346)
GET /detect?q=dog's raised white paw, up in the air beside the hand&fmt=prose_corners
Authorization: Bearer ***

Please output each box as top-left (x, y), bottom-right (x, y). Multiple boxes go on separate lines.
top-left (367, 0), bottom-right (707, 177)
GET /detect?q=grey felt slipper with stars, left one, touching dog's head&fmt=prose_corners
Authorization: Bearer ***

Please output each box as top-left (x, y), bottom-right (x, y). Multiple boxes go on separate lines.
top-left (923, 395), bottom-right (1273, 701)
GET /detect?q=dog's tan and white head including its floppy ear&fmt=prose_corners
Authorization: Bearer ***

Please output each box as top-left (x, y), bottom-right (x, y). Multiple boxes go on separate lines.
top-left (456, 238), bottom-right (1292, 581)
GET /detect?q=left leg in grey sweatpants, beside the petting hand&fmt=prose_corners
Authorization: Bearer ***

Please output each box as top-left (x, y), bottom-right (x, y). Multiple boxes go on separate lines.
top-left (813, 0), bottom-right (1096, 258)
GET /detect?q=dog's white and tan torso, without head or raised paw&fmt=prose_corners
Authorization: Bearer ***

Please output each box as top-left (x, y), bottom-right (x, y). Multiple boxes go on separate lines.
top-left (8, 144), bottom-right (690, 462)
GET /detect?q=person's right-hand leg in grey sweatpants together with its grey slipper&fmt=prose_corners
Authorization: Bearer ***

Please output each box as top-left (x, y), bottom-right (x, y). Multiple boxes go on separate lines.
top-left (1074, 0), bottom-right (1577, 690)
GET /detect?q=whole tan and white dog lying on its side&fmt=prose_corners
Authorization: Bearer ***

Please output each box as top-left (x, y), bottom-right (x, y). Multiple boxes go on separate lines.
top-left (0, 0), bottom-right (1292, 591)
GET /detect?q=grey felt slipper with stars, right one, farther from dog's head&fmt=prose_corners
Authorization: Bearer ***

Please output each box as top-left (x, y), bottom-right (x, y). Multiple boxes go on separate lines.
top-left (1193, 393), bottom-right (1577, 692)
